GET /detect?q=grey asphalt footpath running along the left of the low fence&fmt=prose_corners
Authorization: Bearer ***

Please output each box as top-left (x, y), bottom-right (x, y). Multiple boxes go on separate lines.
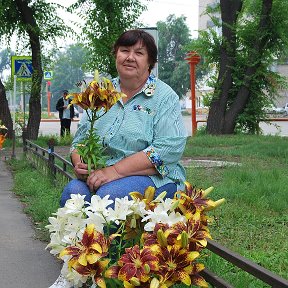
top-left (0, 158), bottom-right (61, 288)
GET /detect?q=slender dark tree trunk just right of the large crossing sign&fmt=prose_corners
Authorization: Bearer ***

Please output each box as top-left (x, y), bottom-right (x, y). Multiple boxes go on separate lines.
top-left (15, 0), bottom-right (43, 140)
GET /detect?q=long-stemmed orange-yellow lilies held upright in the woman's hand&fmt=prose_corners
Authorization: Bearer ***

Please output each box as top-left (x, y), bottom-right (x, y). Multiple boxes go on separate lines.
top-left (67, 71), bottom-right (125, 173)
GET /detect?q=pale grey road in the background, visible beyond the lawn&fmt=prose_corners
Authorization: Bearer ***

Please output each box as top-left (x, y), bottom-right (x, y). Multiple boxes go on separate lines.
top-left (39, 114), bottom-right (288, 136)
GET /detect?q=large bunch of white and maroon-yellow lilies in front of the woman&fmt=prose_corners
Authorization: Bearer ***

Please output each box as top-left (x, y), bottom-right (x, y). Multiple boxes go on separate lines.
top-left (47, 182), bottom-right (224, 288)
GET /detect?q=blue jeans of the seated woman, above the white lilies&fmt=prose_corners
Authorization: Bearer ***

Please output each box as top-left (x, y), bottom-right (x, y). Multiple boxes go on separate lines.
top-left (60, 176), bottom-right (177, 207)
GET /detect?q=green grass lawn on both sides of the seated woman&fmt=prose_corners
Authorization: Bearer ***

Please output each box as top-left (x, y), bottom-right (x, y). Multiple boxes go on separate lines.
top-left (5, 135), bottom-right (288, 288)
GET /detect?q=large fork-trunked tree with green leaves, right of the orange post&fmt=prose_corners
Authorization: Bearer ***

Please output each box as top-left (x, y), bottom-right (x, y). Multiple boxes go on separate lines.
top-left (189, 0), bottom-right (288, 134)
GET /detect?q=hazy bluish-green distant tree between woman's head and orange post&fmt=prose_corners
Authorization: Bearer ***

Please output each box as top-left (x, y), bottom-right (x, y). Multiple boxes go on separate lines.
top-left (157, 15), bottom-right (191, 98)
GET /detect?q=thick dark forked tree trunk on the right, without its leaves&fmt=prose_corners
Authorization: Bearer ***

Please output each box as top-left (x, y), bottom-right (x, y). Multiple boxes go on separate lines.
top-left (207, 0), bottom-right (273, 135)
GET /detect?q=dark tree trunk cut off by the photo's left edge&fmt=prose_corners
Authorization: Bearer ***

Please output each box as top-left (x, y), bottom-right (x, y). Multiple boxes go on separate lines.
top-left (0, 79), bottom-right (13, 139)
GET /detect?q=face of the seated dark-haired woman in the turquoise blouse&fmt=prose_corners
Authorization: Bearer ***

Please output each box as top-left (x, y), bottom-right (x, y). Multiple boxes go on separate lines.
top-left (116, 41), bottom-right (150, 79)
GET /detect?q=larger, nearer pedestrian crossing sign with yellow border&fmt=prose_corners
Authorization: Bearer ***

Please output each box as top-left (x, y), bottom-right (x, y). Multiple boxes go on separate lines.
top-left (11, 56), bottom-right (33, 81)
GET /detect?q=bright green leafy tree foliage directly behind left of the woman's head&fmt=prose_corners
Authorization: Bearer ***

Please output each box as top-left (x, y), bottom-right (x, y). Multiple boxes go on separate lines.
top-left (70, 0), bottom-right (145, 76)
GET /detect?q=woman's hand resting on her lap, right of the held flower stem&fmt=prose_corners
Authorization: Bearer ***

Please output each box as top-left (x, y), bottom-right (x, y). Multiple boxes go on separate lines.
top-left (86, 166), bottom-right (121, 191)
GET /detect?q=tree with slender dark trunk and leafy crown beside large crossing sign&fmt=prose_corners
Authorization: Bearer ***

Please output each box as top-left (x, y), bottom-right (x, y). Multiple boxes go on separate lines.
top-left (0, 0), bottom-right (71, 139)
